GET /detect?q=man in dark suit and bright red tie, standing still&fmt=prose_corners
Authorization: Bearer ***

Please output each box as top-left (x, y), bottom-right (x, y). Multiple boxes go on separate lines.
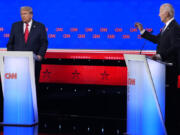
top-left (7, 7), bottom-right (48, 88)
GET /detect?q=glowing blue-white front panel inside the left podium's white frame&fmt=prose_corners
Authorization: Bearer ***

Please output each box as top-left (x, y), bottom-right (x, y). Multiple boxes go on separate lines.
top-left (3, 57), bottom-right (34, 125)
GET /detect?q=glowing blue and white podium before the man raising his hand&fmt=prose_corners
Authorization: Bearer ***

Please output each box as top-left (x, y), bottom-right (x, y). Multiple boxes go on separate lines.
top-left (124, 54), bottom-right (167, 135)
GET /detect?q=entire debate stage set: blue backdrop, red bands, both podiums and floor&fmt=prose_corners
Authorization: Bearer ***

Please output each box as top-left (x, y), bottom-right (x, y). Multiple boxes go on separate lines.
top-left (0, 0), bottom-right (180, 135)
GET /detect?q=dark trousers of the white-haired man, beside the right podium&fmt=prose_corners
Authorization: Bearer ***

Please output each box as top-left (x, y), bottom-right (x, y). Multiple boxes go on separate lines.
top-left (165, 66), bottom-right (180, 135)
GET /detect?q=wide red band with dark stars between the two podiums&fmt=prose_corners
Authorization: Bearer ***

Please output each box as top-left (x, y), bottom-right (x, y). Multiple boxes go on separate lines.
top-left (40, 65), bottom-right (127, 86)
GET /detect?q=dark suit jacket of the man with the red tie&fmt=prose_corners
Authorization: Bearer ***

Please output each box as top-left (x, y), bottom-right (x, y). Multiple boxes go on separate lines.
top-left (7, 20), bottom-right (48, 57)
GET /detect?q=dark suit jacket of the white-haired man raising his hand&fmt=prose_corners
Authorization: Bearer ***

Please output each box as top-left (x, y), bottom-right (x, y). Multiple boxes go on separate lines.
top-left (142, 20), bottom-right (180, 71)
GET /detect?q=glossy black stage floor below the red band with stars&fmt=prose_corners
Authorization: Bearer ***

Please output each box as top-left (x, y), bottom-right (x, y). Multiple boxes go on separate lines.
top-left (0, 84), bottom-right (126, 135)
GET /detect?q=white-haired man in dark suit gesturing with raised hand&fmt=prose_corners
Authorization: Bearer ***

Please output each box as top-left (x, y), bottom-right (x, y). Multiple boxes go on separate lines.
top-left (135, 3), bottom-right (180, 134)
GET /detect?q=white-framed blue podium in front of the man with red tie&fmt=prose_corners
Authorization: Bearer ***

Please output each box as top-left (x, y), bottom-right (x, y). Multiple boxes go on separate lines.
top-left (0, 51), bottom-right (38, 126)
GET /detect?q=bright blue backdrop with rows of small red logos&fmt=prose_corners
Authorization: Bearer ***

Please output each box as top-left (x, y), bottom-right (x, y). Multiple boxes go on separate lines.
top-left (0, 0), bottom-right (180, 50)
